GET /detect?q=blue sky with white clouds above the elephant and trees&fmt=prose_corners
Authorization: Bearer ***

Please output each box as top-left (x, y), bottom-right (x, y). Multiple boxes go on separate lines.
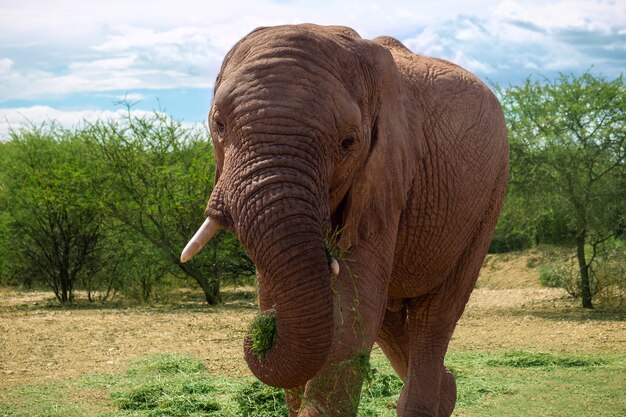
top-left (0, 0), bottom-right (626, 138)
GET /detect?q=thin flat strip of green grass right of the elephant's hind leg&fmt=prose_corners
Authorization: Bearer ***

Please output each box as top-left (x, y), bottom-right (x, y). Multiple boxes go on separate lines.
top-left (487, 351), bottom-right (605, 368)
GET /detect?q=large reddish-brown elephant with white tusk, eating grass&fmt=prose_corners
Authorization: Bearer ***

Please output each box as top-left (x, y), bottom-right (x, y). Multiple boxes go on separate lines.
top-left (181, 24), bottom-right (508, 417)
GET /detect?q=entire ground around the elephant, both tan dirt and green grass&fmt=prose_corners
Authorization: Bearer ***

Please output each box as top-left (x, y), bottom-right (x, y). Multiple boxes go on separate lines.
top-left (0, 249), bottom-right (626, 417)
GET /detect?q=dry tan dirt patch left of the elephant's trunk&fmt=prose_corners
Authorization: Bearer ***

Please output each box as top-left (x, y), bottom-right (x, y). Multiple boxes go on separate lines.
top-left (0, 294), bottom-right (255, 388)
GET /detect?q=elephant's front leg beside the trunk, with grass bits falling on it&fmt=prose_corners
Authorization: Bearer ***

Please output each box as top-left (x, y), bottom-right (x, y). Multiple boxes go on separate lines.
top-left (298, 231), bottom-right (395, 417)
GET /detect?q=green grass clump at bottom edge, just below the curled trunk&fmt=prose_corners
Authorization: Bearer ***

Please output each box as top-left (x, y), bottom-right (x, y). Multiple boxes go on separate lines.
top-left (235, 381), bottom-right (289, 417)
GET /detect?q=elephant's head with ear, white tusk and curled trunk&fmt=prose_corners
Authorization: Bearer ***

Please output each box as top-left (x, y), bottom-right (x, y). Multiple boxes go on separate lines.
top-left (182, 25), bottom-right (420, 388)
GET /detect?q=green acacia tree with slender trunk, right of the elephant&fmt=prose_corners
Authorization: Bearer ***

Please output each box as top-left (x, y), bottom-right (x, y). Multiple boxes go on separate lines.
top-left (498, 72), bottom-right (626, 308)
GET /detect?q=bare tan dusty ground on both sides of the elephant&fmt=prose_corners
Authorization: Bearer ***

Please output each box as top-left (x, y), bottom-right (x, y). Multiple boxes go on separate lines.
top-left (0, 251), bottom-right (626, 389)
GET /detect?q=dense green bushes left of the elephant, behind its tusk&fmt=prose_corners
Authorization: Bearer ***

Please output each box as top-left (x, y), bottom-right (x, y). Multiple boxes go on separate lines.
top-left (0, 113), bottom-right (254, 303)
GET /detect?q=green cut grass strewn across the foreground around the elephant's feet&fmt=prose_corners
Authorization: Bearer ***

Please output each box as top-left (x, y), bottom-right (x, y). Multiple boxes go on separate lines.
top-left (0, 351), bottom-right (626, 417)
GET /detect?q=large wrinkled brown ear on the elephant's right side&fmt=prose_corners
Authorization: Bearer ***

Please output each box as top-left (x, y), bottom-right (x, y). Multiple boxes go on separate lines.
top-left (339, 38), bottom-right (423, 248)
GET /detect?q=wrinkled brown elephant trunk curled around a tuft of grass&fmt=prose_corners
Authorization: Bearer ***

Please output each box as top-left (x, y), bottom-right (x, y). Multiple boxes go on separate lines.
top-left (208, 159), bottom-right (334, 388)
